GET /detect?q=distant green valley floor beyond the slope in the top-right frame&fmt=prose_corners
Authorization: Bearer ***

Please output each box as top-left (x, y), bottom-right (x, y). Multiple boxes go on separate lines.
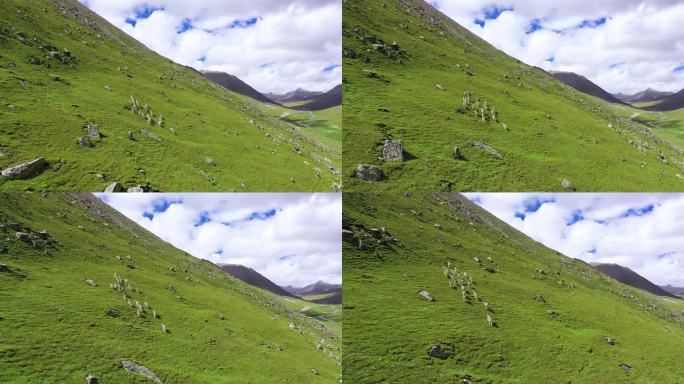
top-left (614, 105), bottom-right (684, 152)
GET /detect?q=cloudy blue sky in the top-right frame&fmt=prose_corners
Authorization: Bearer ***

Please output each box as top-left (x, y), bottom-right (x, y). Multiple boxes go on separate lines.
top-left (430, 0), bottom-right (684, 93)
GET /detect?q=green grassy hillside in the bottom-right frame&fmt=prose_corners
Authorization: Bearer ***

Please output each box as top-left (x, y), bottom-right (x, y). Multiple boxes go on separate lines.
top-left (343, 193), bottom-right (684, 384)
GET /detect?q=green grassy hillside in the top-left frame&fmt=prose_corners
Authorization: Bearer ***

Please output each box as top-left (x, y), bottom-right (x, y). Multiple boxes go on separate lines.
top-left (0, 0), bottom-right (341, 191)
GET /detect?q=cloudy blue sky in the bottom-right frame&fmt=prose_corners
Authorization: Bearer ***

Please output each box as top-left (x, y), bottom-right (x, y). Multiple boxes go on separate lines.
top-left (466, 193), bottom-right (684, 286)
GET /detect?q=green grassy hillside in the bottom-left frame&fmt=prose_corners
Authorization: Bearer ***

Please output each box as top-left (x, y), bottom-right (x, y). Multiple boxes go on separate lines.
top-left (0, 193), bottom-right (341, 384)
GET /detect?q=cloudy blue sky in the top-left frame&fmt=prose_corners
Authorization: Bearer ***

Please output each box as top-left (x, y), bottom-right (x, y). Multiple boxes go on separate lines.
top-left (81, 0), bottom-right (342, 93)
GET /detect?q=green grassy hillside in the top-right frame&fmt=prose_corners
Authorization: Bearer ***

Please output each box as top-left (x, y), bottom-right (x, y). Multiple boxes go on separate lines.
top-left (343, 0), bottom-right (684, 191)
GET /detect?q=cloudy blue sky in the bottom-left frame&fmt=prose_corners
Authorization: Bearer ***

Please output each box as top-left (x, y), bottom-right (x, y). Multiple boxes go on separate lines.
top-left (97, 193), bottom-right (342, 286)
